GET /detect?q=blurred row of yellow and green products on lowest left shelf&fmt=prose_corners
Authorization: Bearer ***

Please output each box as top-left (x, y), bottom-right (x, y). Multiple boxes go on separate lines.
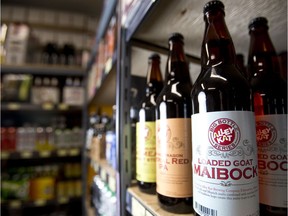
top-left (1, 163), bottom-right (82, 201)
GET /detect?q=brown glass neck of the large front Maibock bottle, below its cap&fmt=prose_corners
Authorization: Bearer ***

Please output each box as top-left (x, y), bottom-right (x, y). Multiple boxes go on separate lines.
top-left (201, 10), bottom-right (236, 67)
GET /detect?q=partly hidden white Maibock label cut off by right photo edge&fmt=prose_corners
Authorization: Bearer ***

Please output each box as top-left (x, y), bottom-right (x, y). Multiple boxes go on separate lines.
top-left (256, 114), bottom-right (287, 208)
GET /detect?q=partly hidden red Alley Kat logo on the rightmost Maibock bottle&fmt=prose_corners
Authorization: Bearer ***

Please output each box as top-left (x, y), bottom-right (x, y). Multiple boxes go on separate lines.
top-left (256, 121), bottom-right (277, 147)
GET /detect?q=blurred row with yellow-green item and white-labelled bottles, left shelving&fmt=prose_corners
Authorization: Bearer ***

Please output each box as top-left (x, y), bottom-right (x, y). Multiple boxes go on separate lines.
top-left (1, 74), bottom-right (84, 106)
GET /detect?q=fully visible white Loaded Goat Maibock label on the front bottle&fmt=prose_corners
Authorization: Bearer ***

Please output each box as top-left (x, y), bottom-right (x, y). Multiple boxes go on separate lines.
top-left (191, 111), bottom-right (259, 216)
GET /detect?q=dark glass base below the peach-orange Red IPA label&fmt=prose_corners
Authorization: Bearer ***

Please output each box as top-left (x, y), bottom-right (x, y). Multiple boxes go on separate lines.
top-left (157, 193), bottom-right (194, 214)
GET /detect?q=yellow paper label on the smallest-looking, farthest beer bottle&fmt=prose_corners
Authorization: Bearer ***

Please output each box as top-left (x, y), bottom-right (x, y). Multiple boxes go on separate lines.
top-left (136, 121), bottom-right (156, 183)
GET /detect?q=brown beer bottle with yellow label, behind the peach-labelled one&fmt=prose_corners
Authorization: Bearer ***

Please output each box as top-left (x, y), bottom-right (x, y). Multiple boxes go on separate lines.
top-left (136, 53), bottom-right (163, 194)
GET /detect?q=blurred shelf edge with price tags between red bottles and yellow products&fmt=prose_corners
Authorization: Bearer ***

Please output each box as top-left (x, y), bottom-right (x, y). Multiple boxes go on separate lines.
top-left (1, 148), bottom-right (81, 160)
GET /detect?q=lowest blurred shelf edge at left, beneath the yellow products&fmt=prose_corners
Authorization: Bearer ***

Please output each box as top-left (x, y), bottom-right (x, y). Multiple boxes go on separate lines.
top-left (1, 197), bottom-right (81, 209)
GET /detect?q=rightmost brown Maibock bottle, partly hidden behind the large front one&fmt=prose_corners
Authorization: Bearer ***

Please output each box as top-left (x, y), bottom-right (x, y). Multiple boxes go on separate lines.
top-left (248, 17), bottom-right (287, 216)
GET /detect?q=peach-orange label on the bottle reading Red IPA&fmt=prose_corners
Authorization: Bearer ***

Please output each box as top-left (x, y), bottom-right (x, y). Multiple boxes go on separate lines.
top-left (156, 118), bottom-right (192, 198)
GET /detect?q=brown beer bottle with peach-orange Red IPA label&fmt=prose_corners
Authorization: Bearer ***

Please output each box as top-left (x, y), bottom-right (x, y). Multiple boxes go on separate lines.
top-left (156, 33), bottom-right (193, 213)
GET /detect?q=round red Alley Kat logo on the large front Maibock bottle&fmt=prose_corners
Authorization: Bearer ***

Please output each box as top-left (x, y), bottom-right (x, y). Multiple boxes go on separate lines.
top-left (208, 118), bottom-right (241, 151)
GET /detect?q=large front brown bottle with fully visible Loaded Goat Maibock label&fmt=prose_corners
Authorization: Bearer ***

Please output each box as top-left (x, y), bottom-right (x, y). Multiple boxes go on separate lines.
top-left (191, 1), bottom-right (259, 216)
